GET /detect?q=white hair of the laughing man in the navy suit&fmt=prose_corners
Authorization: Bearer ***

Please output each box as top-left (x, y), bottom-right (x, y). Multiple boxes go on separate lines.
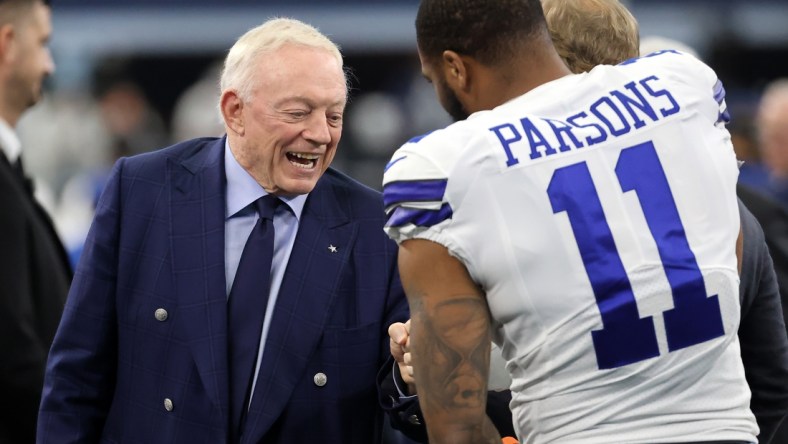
top-left (219, 18), bottom-right (343, 100)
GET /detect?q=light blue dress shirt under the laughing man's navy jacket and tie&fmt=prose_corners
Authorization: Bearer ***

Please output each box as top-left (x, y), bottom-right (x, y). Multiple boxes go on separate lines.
top-left (224, 142), bottom-right (307, 403)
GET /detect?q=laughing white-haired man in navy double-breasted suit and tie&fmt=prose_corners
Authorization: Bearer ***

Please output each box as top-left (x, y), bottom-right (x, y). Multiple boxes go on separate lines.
top-left (38, 19), bottom-right (407, 444)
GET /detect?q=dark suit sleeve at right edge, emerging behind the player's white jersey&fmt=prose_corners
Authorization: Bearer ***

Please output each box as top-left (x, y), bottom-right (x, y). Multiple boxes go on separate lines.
top-left (739, 203), bottom-right (788, 443)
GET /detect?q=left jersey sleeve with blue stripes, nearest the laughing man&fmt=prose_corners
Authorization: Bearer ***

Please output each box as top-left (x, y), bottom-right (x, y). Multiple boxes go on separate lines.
top-left (383, 133), bottom-right (453, 250)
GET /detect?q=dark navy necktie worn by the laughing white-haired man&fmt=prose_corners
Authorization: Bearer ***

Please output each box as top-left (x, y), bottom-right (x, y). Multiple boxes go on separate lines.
top-left (227, 194), bottom-right (282, 442)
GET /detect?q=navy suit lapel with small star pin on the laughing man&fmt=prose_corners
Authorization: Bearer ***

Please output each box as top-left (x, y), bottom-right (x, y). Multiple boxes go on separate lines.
top-left (243, 177), bottom-right (356, 443)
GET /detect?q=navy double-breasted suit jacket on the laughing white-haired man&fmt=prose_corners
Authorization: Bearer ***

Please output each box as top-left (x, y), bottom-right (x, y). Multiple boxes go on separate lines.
top-left (38, 138), bottom-right (408, 444)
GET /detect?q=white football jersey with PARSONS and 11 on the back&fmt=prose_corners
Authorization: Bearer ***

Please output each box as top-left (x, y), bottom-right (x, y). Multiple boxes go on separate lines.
top-left (384, 51), bottom-right (758, 444)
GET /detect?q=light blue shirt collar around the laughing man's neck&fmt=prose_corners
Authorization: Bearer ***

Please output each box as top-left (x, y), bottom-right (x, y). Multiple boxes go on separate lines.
top-left (225, 140), bottom-right (308, 220)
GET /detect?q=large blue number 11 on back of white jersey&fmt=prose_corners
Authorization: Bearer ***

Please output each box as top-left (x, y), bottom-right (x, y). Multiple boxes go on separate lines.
top-left (547, 142), bottom-right (725, 369)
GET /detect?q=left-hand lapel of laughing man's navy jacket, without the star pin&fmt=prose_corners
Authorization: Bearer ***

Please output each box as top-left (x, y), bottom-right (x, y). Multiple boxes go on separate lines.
top-left (168, 138), bottom-right (229, 424)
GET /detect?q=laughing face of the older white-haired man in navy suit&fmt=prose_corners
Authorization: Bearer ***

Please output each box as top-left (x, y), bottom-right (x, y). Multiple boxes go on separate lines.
top-left (230, 44), bottom-right (347, 196)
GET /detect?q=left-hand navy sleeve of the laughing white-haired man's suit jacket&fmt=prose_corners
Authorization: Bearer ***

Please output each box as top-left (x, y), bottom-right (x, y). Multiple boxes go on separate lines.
top-left (37, 159), bottom-right (123, 444)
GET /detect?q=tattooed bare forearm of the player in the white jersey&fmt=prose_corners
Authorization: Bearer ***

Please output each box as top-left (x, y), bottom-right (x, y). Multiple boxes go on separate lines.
top-left (409, 295), bottom-right (501, 444)
